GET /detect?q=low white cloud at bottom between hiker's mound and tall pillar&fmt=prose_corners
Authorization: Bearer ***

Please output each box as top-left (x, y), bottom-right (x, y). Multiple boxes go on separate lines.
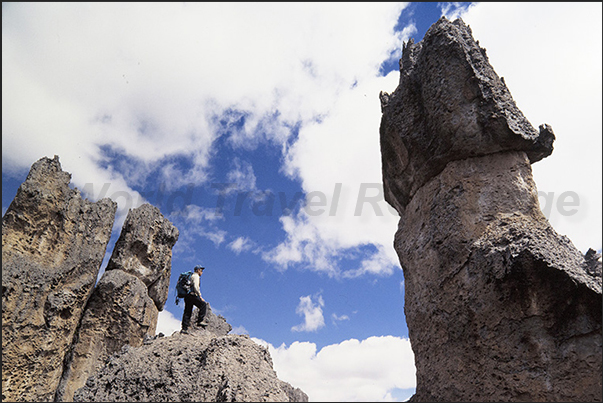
top-left (252, 336), bottom-right (416, 402)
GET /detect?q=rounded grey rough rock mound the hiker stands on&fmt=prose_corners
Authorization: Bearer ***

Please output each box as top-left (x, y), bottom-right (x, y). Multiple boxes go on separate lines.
top-left (74, 329), bottom-right (308, 402)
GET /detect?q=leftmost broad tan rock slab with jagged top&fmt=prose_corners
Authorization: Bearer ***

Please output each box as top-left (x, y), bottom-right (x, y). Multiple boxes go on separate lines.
top-left (2, 156), bottom-right (117, 402)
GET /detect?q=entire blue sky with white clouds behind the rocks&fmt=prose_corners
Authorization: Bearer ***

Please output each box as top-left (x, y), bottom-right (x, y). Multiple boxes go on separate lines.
top-left (2, 3), bottom-right (602, 401)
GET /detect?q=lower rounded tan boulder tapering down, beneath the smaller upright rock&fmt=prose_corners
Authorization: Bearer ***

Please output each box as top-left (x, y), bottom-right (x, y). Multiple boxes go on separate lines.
top-left (56, 270), bottom-right (159, 401)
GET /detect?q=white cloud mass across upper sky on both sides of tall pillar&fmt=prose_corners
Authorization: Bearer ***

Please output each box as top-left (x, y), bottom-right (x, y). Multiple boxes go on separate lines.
top-left (2, 3), bottom-right (603, 276)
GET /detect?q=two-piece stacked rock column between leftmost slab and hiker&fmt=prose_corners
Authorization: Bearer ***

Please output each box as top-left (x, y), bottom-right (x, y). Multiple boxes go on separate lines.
top-left (56, 204), bottom-right (179, 401)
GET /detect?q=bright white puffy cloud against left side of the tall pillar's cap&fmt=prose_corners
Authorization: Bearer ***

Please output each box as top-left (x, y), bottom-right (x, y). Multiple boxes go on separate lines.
top-left (265, 72), bottom-right (406, 276)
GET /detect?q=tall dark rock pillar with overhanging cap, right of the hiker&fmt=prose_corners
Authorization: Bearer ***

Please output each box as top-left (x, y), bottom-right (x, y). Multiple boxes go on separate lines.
top-left (380, 18), bottom-right (602, 401)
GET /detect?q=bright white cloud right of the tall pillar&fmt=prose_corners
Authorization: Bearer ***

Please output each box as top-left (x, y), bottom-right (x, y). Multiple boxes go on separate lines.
top-left (461, 2), bottom-right (603, 252)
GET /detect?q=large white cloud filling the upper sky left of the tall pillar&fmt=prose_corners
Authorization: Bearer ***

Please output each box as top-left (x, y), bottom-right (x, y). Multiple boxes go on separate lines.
top-left (2, 3), bottom-right (413, 266)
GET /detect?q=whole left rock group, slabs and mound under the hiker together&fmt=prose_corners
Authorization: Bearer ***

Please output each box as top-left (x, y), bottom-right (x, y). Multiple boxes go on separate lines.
top-left (2, 156), bottom-right (308, 401)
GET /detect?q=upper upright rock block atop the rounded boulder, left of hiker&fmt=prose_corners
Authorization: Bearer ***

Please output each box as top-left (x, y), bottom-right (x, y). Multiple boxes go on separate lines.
top-left (106, 203), bottom-right (179, 311)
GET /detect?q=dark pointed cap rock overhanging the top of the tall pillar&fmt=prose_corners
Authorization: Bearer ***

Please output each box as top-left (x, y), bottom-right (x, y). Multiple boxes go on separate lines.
top-left (380, 18), bottom-right (555, 215)
